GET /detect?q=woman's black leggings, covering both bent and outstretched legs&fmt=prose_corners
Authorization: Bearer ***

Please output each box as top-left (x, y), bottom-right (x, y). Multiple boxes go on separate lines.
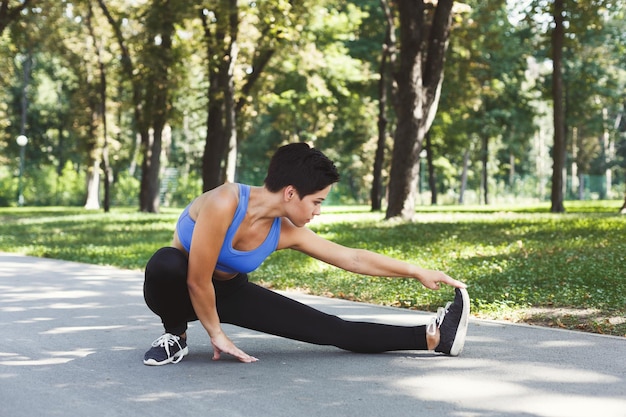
top-left (143, 247), bottom-right (427, 353)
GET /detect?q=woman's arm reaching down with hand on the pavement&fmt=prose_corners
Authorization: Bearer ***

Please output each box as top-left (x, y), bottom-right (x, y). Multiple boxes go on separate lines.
top-left (187, 187), bottom-right (256, 362)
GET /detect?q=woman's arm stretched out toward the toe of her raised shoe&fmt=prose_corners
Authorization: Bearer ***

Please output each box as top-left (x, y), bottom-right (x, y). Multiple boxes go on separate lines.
top-left (285, 226), bottom-right (466, 290)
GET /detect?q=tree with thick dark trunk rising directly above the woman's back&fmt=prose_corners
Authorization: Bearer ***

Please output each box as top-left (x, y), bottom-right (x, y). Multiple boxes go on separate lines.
top-left (200, 0), bottom-right (304, 190)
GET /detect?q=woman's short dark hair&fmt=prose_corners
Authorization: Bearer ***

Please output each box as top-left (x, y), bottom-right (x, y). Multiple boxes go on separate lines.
top-left (264, 143), bottom-right (339, 198)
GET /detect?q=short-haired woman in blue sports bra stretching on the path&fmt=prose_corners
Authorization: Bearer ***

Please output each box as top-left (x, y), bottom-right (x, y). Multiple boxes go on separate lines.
top-left (144, 143), bottom-right (469, 365)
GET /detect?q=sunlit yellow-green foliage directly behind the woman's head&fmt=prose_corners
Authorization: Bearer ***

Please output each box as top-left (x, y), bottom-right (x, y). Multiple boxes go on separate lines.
top-left (238, 0), bottom-right (382, 204)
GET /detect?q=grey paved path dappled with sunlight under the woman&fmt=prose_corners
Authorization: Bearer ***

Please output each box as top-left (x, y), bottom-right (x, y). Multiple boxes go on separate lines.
top-left (0, 253), bottom-right (626, 417)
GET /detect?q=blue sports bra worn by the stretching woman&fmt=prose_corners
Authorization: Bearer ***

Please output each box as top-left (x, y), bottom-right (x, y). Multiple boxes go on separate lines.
top-left (176, 184), bottom-right (281, 274)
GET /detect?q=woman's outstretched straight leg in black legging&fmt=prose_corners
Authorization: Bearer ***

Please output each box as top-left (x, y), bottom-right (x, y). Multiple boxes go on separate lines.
top-left (214, 274), bottom-right (428, 353)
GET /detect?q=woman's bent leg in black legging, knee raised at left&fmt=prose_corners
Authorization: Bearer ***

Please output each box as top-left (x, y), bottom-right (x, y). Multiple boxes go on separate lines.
top-left (143, 247), bottom-right (198, 336)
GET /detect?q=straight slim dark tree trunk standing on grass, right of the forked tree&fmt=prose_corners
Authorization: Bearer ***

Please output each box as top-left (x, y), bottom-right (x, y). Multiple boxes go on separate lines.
top-left (550, 0), bottom-right (566, 213)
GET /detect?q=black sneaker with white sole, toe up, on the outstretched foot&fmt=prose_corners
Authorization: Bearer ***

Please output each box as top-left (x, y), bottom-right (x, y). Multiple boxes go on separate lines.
top-left (427, 288), bottom-right (470, 356)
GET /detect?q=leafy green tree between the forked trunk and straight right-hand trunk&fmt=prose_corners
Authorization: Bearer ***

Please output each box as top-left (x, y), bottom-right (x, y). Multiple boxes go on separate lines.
top-left (438, 1), bottom-right (534, 204)
